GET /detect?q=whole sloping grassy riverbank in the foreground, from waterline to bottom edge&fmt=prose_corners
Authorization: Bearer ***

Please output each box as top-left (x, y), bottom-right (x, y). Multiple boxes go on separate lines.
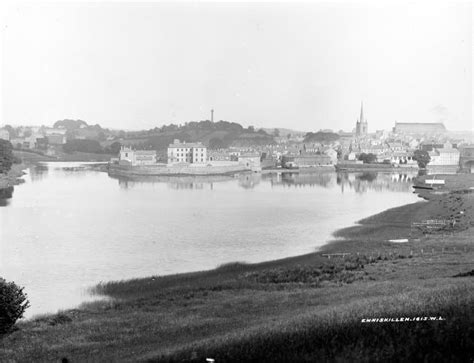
top-left (0, 176), bottom-right (474, 362)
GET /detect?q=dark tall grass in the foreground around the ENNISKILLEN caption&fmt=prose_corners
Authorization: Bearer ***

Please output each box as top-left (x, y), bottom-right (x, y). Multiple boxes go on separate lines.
top-left (152, 285), bottom-right (474, 362)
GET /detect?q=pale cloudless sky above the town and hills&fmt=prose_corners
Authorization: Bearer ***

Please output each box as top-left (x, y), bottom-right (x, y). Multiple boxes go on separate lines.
top-left (0, 1), bottom-right (474, 131)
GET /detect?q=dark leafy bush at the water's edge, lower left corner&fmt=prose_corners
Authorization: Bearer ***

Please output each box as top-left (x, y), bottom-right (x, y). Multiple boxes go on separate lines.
top-left (0, 278), bottom-right (30, 334)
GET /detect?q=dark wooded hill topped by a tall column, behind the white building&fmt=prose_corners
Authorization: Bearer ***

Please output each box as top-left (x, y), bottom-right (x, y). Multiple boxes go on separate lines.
top-left (121, 121), bottom-right (275, 150)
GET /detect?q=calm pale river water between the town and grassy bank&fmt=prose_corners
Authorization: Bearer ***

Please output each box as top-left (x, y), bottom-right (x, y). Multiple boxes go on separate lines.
top-left (0, 163), bottom-right (419, 317)
